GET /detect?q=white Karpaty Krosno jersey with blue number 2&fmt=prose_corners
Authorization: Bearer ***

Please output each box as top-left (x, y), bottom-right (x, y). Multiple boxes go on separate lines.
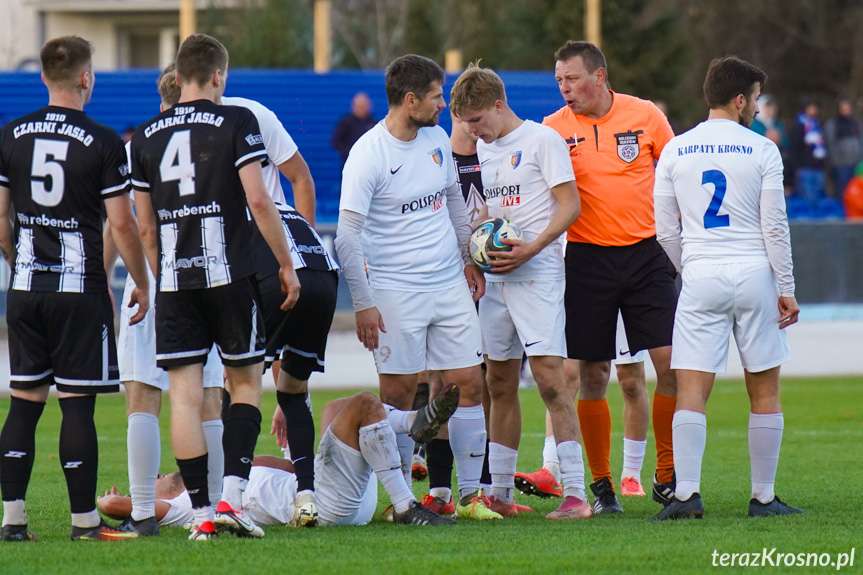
top-left (654, 120), bottom-right (783, 266)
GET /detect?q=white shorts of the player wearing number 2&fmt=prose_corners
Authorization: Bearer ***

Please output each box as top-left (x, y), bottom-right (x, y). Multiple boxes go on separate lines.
top-left (671, 263), bottom-right (791, 373)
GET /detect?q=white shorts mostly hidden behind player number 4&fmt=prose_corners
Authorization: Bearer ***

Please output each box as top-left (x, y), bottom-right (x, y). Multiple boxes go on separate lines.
top-left (117, 274), bottom-right (224, 391)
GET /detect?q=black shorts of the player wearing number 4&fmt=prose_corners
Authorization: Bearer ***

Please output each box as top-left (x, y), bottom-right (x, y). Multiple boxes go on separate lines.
top-left (156, 276), bottom-right (266, 369)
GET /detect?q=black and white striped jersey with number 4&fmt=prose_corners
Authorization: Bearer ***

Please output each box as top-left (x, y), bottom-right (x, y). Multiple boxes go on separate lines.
top-left (132, 100), bottom-right (267, 292)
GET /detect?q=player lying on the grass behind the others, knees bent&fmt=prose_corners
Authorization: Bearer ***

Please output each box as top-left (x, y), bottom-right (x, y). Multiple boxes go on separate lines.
top-left (98, 385), bottom-right (459, 538)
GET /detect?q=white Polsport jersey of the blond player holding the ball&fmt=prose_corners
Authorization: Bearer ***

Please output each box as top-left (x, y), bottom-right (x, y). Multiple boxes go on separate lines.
top-left (477, 120), bottom-right (575, 282)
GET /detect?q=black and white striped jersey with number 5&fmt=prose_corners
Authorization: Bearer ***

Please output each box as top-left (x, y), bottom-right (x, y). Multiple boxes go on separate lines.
top-left (0, 106), bottom-right (129, 293)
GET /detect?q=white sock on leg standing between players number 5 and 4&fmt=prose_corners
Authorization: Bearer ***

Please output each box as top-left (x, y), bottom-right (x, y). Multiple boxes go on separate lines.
top-left (126, 413), bottom-right (162, 521)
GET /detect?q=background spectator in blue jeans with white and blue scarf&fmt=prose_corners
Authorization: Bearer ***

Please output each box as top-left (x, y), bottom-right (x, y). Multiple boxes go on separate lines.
top-left (790, 96), bottom-right (827, 205)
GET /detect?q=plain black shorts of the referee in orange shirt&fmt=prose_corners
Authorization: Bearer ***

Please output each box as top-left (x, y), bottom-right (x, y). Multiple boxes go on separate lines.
top-left (564, 237), bottom-right (677, 361)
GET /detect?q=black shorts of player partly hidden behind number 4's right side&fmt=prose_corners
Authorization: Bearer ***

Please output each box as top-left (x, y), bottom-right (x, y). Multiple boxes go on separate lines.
top-left (258, 268), bottom-right (339, 381)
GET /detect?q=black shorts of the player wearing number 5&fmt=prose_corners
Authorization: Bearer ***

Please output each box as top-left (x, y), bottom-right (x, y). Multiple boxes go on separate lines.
top-left (6, 290), bottom-right (120, 394)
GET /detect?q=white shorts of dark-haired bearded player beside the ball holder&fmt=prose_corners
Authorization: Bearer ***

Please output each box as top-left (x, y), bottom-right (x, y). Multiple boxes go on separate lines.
top-left (372, 282), bottom-right (482, 374)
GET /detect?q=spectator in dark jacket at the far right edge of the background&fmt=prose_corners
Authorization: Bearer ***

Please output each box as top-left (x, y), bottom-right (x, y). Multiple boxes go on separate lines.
top-left (824, 96), bottom-right (863, 198)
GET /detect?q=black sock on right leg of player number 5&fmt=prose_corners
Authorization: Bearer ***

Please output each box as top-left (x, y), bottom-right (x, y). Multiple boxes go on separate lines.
top-left (60, 395), bottom-right (99, 513)
